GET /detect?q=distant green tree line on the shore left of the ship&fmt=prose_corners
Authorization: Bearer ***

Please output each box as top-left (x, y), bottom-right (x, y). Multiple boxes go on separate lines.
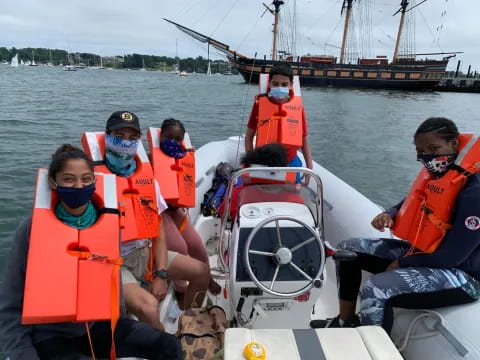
top-left (0, 47), bottom-right (234, 73)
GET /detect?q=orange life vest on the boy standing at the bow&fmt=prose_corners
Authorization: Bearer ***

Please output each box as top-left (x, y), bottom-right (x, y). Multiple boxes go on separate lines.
top-left (255, 95), bottom-right (303, 148)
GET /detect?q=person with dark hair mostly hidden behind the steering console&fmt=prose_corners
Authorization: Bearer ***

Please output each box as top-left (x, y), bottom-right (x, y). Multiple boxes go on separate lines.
top-left (218, 144), bottom-right (303, 219)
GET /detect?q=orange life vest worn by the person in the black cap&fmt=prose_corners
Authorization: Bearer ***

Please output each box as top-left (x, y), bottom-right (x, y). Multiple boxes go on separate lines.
top-left (82, 132), bottom-right (160, 241)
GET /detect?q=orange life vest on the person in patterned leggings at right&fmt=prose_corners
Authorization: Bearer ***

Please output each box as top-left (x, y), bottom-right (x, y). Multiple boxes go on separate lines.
top-left (392, 134), bottom-right (480, 253)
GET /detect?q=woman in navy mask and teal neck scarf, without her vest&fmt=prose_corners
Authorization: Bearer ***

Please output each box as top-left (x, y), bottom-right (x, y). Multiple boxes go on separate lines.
top-left (0, 145), bottom-right (183, 360)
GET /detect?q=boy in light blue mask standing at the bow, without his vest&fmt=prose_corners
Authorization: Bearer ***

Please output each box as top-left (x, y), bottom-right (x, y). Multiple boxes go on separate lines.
top-left (245, 64), bottom-right (313, 184)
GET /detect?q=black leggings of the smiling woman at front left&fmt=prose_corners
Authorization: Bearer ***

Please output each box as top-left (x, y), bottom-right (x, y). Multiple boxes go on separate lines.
top-left (35, 318), bottom-right (183, 360)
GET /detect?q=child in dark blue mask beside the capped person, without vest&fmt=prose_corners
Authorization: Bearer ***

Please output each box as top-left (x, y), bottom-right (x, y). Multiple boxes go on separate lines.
top-left (160, 118), bottom-right (221, 295)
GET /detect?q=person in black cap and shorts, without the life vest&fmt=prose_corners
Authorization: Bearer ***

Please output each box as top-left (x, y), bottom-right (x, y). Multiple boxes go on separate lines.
top-left (105, 111), bottom-right (210, 328)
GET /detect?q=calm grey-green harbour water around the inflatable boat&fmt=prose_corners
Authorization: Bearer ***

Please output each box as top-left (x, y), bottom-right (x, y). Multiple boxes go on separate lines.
top-left (0, 65), bottom-right (480, 275)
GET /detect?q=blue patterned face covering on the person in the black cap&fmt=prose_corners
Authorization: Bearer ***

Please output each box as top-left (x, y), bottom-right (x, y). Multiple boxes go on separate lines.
top-left (105, 134), bottom-right (138, 176)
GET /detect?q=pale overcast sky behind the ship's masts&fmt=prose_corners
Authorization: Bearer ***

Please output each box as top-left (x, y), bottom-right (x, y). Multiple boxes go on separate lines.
top-left (0, 0), bottom-right (480, 71)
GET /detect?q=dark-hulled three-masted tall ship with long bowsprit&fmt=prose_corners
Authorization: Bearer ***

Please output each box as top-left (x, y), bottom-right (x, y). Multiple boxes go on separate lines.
top-left (164, 0), bottom-right (455, 90)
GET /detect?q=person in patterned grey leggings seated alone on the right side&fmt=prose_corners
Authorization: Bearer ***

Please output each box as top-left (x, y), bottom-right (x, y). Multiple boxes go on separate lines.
top-left (318, 118), bottom-right (480, 332)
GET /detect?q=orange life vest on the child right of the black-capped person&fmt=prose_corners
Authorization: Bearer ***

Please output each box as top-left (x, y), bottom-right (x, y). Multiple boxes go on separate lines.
top-left (147, 127), bottom-right (195, 207)
